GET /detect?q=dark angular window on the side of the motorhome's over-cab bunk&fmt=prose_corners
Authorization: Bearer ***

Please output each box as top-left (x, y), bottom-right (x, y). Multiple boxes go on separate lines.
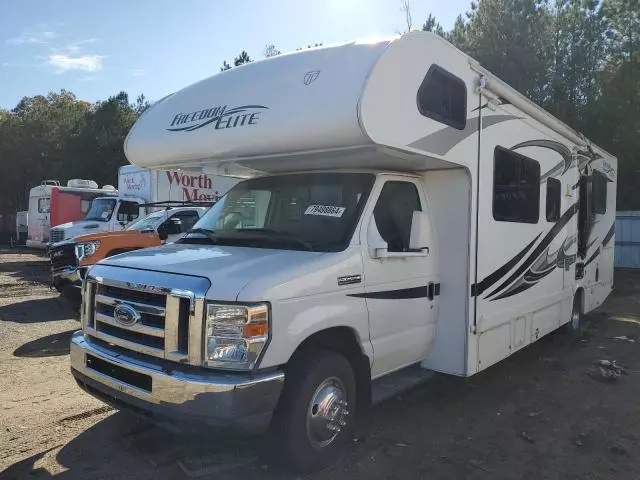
top-left (418, 65), bottom-right (467, 130)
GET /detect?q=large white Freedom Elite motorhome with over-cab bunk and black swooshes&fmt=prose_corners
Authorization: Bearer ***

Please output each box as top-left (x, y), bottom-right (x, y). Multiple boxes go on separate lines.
top-left (71, 32), bottom-right (617, 468)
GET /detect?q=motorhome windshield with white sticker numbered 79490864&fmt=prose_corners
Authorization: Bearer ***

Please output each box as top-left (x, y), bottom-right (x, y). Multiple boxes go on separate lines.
top-left (180, 173), bottom-right (375, 251)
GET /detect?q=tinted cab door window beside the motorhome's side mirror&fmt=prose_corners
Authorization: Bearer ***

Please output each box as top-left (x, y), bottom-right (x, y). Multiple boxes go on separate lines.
top-left (373, 182), bottom-right (422, 252)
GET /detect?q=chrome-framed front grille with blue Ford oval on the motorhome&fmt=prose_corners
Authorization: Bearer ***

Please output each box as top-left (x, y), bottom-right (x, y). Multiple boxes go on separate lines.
top-left (82, 263), bottom-right (211, 365)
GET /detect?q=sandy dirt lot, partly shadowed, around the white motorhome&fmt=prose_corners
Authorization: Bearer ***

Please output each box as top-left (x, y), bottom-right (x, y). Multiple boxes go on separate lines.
top-left (0, 250), bottom-right (640, 480)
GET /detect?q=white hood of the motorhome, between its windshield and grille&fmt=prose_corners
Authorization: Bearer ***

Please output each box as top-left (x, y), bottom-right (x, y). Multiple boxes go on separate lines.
top-left (100, 244), bottom-right (334, 301)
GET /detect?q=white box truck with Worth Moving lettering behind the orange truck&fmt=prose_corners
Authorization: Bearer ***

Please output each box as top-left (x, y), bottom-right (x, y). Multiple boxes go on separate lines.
top-left (51, 165), bottom-right (238, 243)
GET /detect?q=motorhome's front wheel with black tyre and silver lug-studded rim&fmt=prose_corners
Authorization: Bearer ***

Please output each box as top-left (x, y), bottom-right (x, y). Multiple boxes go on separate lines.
top-left (270, 350), bottom-right (356, 471)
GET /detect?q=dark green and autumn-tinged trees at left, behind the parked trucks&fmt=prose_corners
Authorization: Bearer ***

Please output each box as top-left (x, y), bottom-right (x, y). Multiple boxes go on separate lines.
top-left (0, 90), bottom-right (141, 212)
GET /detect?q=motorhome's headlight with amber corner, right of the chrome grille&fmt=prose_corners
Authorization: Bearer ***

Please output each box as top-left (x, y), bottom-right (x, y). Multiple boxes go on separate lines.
top-left (205, 303), bottom-right (269, 370)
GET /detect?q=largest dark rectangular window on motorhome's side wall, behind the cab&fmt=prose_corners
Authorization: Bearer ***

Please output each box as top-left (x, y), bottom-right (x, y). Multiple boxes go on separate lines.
top-left (493, 147), bottom-right (540, 223)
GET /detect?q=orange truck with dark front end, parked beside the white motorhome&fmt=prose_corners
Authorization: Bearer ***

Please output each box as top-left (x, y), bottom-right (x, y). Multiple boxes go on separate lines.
top-left (49, 206), bottom-right (206, 296)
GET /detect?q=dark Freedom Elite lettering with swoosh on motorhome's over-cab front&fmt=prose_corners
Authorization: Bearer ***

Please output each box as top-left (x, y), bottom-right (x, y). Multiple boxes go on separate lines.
top-left (167, 105), bottom-right (269, 132)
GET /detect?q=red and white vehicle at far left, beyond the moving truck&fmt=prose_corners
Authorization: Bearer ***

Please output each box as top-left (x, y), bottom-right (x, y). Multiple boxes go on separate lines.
top-left (26, 179), bottom-right (118, 248)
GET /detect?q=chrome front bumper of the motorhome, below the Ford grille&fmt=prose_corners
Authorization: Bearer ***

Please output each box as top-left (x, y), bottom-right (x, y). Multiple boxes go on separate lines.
top-left (71, 331), bottom-right (284, 435)
